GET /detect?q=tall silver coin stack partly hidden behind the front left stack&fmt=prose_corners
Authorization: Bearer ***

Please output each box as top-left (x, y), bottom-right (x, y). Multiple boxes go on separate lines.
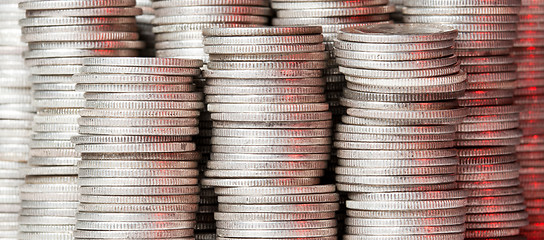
top-left (19, 0), bottom-right (143, 240)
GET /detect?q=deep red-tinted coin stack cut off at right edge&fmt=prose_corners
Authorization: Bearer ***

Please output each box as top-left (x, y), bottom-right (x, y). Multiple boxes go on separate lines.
top-left (513, 0), bottom-right (544, 240)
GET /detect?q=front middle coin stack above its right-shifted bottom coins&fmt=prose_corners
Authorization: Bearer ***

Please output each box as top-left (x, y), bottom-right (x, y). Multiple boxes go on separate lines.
top-left (203, 27), bottom-right (332, 187)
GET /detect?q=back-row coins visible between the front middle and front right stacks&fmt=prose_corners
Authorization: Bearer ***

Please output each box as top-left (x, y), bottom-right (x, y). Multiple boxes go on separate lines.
top-left (271, 0), bottom-right (395, 123)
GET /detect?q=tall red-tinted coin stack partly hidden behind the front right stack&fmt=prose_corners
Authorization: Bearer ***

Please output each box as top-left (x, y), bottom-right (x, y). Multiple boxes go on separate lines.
top-left (403, 0), bottom-right (527, 238)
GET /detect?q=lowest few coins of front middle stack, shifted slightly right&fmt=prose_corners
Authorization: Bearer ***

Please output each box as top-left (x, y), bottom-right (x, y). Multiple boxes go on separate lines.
top-left (215, 185), bottom-right (339, 240)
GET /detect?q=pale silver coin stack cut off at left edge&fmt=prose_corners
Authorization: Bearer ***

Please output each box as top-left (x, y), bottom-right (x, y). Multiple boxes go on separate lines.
top-left (0, 0), bottom-right (29, 239)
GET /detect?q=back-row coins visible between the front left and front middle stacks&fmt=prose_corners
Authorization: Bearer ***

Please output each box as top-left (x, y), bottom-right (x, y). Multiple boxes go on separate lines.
top-left (153, 0), bottom-right (271, 62)
